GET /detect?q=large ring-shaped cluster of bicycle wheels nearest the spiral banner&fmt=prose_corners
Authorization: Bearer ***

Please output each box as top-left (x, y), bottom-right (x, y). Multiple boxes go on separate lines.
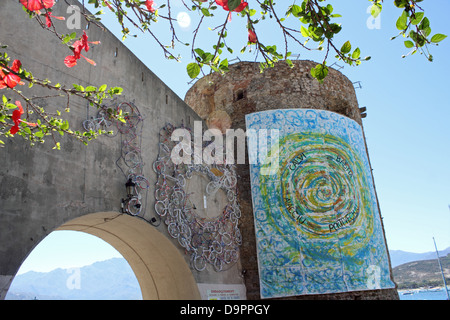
top-left (153, 124), bottom-right (242, 271)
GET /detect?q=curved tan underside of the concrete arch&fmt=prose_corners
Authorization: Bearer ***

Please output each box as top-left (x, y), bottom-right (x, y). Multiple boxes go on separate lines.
top-left (57, 212), bottom-right (200, 300)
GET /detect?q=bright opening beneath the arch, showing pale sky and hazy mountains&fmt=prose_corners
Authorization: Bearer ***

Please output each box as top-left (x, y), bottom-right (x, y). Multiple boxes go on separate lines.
top-left (5, 230), bottom-right (142, 300)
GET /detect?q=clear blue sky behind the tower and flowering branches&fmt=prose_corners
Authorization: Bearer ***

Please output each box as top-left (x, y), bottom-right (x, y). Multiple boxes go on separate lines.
top-left (17, 0), bottom-right (450, 274)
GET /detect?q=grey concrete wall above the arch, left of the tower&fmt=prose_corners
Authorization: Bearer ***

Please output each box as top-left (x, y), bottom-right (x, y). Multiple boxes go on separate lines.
top-left (0, 0), bottom-right (244, 298)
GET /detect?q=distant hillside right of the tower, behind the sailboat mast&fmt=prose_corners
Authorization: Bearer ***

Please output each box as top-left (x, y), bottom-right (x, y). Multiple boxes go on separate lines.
top-left (392, 254), bottom-right (450, 289)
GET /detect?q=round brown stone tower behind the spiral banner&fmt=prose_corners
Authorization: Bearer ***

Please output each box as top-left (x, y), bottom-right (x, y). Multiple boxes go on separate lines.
top-left (185, 61), bottom-right (398, 299)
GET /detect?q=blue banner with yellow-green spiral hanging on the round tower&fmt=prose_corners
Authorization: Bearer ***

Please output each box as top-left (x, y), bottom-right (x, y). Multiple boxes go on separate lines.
top-left (246, 109), bottom-right (394, 298)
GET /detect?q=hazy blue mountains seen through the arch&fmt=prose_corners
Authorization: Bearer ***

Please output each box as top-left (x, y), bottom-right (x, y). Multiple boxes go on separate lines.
top-left (6, 258), bottom-right (142, 300)
